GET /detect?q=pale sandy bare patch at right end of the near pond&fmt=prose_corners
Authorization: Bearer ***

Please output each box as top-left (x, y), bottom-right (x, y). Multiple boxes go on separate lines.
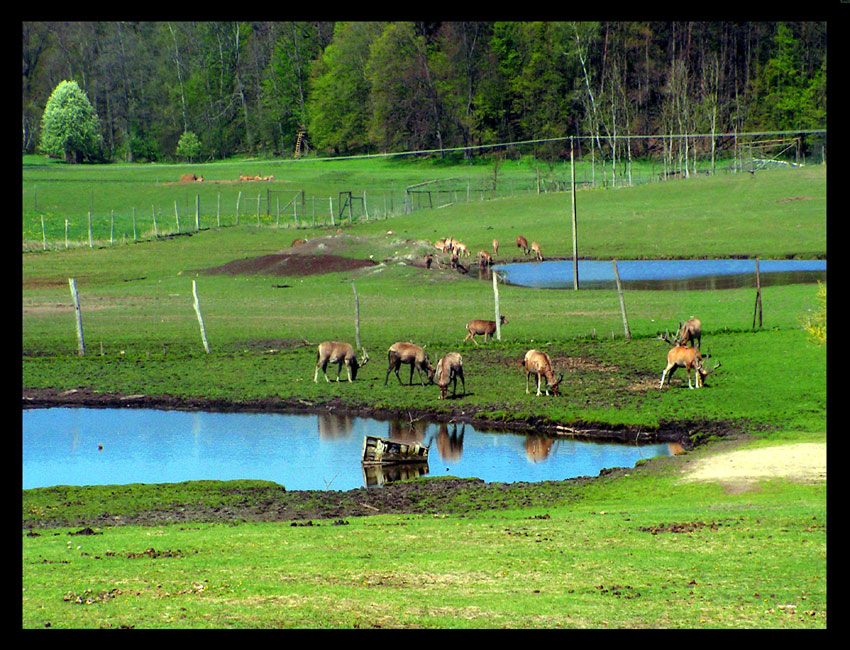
top-left (683, 443), bottom-right (826, 490)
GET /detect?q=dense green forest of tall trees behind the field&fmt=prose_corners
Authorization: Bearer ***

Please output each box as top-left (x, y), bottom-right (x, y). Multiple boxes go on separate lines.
top-left (22, 21), bottom-right (827, 162)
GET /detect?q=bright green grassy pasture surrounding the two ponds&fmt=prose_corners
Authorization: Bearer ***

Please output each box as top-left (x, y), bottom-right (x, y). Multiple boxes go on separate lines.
top-left (22, 156), bottom-right (826, 628)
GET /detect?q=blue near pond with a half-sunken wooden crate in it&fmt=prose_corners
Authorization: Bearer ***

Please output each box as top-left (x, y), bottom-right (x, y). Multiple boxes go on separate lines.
top-left (18, 408), bottom-right (679, 490)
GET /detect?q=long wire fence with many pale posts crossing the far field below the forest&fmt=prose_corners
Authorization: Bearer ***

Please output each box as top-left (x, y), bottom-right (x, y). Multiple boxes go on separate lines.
top-left (23, 131), bottom-right (826, 251)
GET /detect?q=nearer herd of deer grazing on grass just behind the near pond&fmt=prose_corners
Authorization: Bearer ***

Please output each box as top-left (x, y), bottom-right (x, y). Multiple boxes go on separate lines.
top-left (313, 316), bottom-right (720, 399)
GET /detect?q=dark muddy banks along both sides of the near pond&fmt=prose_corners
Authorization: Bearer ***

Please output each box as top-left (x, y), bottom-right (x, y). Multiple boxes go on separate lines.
top-left (22, 388), bottom-right (746, 535)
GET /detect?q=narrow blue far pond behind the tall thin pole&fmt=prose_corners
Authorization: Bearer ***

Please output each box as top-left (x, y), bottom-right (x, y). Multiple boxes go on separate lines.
top-left (486, 259), bottom-right (826, 291)
